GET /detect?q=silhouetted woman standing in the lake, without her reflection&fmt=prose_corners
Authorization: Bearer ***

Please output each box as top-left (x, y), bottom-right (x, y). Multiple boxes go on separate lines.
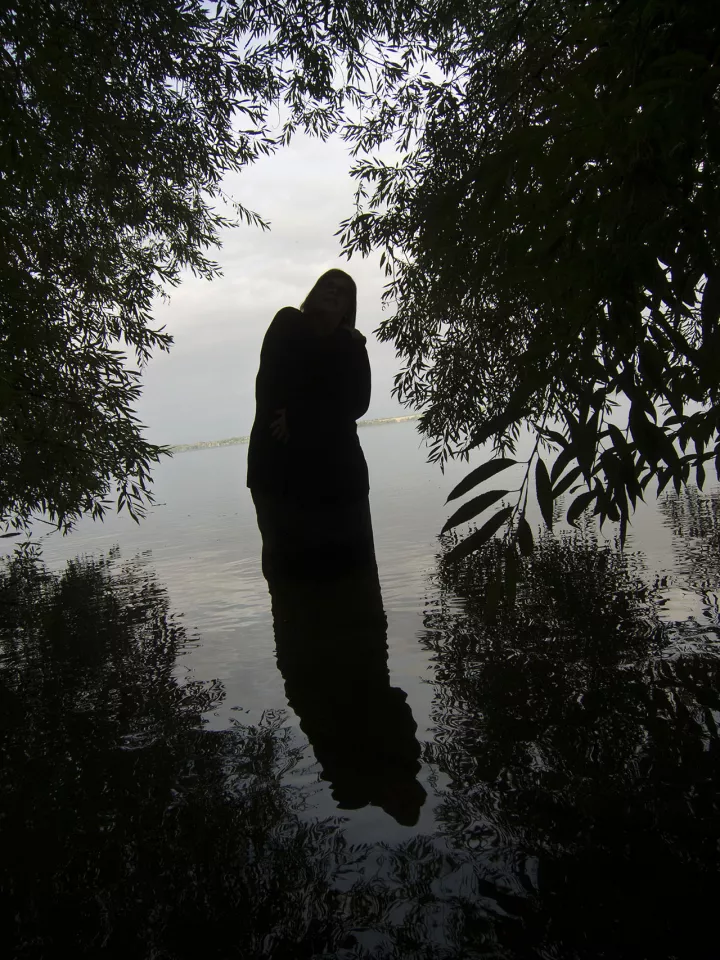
top-left (247, 270), bottom-right (374, 581)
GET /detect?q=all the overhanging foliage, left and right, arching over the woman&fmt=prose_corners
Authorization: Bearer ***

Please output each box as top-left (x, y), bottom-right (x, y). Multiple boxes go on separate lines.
top-left (7, 0), bottom-right (720, 545)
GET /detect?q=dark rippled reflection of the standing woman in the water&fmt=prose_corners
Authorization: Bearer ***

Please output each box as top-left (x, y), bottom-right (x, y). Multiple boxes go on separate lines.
top-left (270, 562), bottom-right (425, 826)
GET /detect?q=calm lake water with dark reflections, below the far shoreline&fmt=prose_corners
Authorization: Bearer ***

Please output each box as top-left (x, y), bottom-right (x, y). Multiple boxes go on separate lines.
top-left (0, 423), bottom-right (720, 958)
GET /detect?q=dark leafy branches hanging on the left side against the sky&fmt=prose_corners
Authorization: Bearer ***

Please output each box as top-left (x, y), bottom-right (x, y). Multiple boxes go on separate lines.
top-left (0, 0), bottom-right (422, 528)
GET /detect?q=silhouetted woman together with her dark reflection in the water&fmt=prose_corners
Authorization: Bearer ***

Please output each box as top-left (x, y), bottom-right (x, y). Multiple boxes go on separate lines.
top-left (248, 270), bottom-right (425, 825)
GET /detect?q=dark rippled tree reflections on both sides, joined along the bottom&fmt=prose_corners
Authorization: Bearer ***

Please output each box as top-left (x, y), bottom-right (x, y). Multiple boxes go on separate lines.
top-left (8, 538), bottom-right (720, 960)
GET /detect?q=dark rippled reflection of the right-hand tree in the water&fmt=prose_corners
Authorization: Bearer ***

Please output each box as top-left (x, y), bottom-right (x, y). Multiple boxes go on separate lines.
top-left (426, 536), bottom-right (720, 957)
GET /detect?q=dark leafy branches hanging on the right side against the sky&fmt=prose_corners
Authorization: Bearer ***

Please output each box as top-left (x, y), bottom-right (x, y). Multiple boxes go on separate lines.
top-left (343, 0), bottom-right (720, 549)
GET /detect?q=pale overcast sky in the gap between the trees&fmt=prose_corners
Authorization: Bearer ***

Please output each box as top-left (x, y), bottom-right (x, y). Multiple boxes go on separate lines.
top-left (138, 131), bottom-right (409, 444)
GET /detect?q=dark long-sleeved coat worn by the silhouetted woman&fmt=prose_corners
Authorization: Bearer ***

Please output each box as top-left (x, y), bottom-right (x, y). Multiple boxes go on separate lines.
top-left (247, 307), bottom-right (370, 503)
